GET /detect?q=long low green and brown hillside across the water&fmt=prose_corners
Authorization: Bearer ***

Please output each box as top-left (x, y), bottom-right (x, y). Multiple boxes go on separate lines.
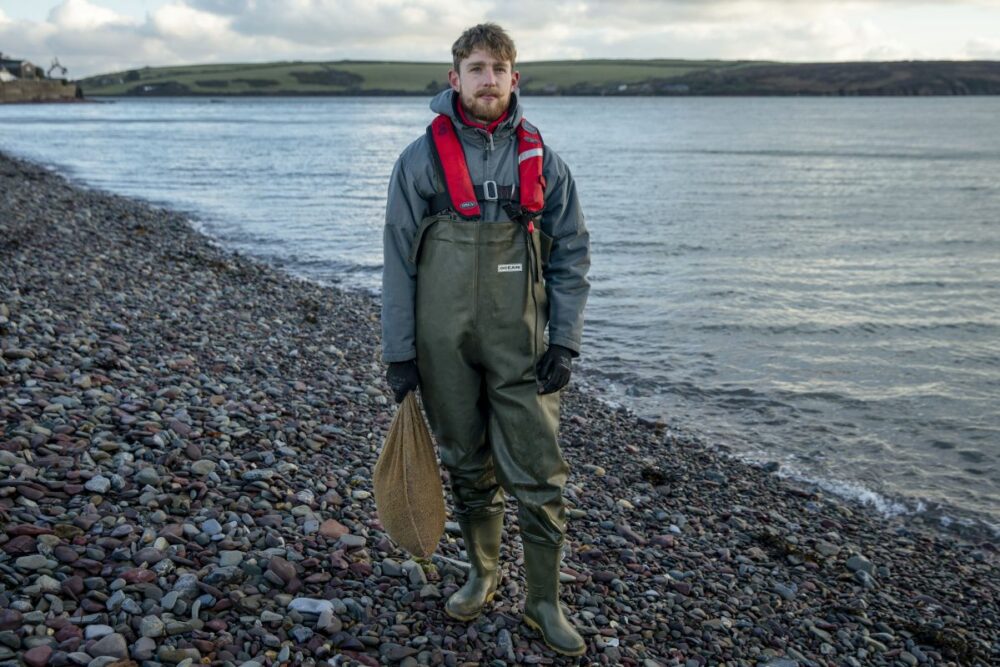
top-left (78, 60), bottom-right (1000, 97)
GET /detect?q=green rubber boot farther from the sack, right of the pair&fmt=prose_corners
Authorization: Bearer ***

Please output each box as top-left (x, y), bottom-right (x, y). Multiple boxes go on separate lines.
top-left (522, 540), bottom-right (587, 656)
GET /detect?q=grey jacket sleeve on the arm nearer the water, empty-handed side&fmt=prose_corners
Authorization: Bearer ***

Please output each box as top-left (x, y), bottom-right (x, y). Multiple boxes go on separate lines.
top-left (542, 147), bottom-right (590, 356)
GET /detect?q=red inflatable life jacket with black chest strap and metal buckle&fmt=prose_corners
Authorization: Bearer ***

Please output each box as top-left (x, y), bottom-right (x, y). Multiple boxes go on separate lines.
top-left (427, 114), bottom-right (545, 232)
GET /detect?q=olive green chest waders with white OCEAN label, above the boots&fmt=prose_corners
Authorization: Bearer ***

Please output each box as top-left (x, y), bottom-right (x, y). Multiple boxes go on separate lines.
top-left (411, 215), bottom-right (567, 547)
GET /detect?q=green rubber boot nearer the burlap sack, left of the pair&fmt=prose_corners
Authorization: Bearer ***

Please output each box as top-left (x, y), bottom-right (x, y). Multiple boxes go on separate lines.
top-left (444, 513), bottom-right (503, 621)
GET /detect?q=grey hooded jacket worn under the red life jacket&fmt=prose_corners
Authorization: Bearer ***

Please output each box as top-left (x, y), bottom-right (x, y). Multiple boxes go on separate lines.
top-left (382, 90), bottom-right (590, 362)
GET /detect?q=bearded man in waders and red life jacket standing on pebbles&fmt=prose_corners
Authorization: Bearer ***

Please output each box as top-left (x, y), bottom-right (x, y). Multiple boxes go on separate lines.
top-left (382, 23), bottom-right (590, 655)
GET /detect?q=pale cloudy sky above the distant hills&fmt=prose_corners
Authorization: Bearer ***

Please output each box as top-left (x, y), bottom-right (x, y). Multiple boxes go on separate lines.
top-left (0, 0), bottom-right (1000, 78)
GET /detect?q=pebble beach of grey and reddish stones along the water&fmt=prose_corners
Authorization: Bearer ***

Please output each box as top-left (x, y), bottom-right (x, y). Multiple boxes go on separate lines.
top-left (0, 153), bottom-right (1000, 665)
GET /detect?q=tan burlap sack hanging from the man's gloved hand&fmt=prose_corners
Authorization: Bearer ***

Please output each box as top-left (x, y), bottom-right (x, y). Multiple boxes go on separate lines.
top-left (372, 391), bottom-right (445, 558)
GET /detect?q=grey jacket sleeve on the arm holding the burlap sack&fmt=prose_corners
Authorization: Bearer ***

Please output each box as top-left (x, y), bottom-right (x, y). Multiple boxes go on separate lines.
top-left (382, 145), bottom-right (427, 363)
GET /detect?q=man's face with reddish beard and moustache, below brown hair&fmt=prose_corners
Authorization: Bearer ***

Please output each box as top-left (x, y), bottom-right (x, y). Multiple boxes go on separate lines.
top-left (448, 49), bottom-right (521, 124)
